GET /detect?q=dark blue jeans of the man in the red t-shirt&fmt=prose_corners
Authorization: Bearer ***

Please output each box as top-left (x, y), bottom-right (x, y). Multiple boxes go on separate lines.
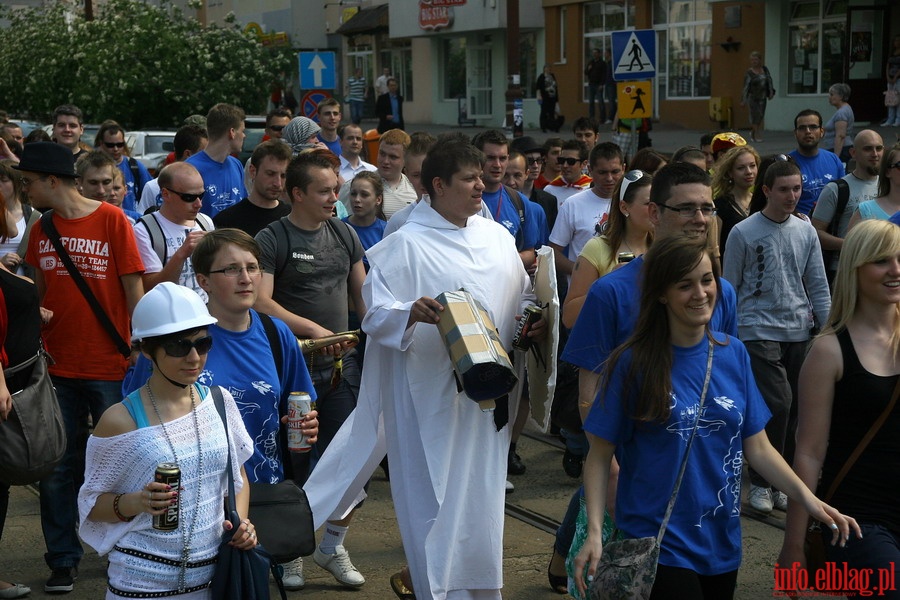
top-left (40, 377), bottom-right (122, 569)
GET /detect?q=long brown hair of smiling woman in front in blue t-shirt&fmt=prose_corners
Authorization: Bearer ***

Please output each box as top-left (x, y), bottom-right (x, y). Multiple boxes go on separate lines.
top-left (601, 236), bottom-right (722, 422)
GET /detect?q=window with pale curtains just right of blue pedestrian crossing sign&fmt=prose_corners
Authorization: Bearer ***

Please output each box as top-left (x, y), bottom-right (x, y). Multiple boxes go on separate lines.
top-left (653, 0), bottom-right (712, 99)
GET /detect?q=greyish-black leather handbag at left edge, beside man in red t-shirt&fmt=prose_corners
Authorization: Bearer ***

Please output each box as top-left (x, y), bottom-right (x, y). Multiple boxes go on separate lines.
top-left (0, 349), bottom-right (66, 485)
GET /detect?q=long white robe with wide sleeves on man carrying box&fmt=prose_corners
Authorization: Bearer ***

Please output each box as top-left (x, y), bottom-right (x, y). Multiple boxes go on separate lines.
top-left (304, 202), bottom-right (533, 600)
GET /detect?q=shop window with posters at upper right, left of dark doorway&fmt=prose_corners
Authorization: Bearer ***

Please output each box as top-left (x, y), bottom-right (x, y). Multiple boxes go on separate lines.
top-left (787, 0), bottom-right (847, 94)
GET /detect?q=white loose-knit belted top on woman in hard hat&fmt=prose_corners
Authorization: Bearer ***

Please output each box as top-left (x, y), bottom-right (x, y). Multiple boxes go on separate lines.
top-left (78, 387), bottom-right (253, 597)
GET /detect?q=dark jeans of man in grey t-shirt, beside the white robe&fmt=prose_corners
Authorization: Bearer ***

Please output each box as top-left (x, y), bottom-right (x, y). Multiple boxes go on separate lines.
top-left (291, 350), bottom-right (361, 487)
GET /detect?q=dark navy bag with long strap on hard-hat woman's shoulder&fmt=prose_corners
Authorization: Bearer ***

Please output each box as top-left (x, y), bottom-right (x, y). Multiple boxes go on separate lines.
top-left (210, 386), bottom-right (287, 600)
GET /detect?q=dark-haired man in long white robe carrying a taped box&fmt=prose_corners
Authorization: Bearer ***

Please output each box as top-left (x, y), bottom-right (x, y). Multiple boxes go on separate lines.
top-left (360, 137), bottom-right (543, 600)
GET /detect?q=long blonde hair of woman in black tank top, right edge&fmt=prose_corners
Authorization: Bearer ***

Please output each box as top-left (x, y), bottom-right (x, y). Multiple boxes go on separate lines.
top-left (822, 219), bottom-right (900, 355)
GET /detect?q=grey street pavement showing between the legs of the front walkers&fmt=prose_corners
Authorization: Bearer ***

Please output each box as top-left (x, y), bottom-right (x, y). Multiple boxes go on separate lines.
top-left (7, 432), bottom-right (796, 600)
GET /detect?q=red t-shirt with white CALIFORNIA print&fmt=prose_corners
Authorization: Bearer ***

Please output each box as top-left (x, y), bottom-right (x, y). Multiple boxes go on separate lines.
top-left (25, 202), bottom-right (144, 381)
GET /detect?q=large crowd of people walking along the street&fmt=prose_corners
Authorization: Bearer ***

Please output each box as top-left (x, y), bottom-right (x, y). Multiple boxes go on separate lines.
top-left (0, 75), bottom-right (900, 600)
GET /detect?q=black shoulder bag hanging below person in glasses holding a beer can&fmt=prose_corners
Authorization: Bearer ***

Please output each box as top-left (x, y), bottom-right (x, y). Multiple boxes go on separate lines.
top-left (249, 480), bottom-right (316, 564)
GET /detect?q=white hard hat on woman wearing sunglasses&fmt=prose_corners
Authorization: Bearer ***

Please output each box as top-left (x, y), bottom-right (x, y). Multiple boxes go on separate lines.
top-left (131, 281), bottom-right (218, 342)
